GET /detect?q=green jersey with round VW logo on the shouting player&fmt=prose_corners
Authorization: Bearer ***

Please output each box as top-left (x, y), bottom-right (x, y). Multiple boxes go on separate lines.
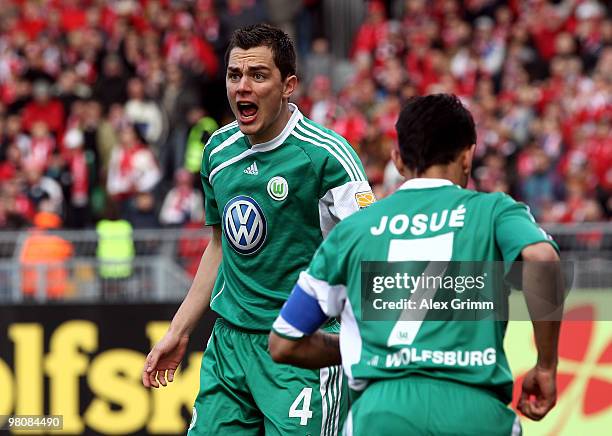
top-left (201, 104), bottom-right (373, 331)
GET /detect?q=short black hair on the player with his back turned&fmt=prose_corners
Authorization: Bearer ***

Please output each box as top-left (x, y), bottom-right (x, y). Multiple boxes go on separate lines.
top-left (395, 94), bottom-right (476, 174)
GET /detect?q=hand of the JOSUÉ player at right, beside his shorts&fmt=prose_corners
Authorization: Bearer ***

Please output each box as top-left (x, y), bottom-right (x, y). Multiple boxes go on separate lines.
top-left (516, 366), bottom-right (557, 421)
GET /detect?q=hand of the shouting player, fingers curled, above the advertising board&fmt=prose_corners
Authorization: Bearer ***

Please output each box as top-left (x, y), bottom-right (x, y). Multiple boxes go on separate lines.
top-left (142, 332), bottom-right (189, 388)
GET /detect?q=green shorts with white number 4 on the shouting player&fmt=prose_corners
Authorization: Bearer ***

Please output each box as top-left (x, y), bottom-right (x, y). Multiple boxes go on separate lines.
top-left (188, 319), bottom-right (348, 436)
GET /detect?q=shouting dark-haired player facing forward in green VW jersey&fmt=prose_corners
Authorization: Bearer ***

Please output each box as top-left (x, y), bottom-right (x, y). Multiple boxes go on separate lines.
top-left (143, 25), bottom-right (373, 435)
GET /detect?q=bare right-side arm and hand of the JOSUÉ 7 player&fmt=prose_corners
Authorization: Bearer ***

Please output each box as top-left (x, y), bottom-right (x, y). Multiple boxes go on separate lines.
top-left (517, 242), bottom-right (564, 421)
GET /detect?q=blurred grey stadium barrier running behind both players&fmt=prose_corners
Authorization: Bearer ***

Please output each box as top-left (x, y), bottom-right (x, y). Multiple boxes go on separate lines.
top-left (0, 223), bottom-right (612, 303)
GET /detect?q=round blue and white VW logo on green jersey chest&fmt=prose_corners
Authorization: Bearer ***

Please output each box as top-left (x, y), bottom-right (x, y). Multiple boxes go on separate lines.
top-left (223, 195), bottom-right (267, 255)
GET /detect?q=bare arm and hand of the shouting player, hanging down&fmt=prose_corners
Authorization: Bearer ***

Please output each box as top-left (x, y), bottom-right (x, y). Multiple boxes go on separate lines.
top-left (142, 225), bottom-right (222, 388)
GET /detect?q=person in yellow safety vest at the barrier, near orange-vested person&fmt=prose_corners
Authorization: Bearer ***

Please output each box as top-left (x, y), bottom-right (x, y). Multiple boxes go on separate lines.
top-left (96, 206), bottom-right (134, 298)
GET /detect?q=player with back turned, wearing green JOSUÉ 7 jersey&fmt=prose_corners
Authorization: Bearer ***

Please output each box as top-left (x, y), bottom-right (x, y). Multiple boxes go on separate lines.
top-left (270, 94), bottom-right (561, 435)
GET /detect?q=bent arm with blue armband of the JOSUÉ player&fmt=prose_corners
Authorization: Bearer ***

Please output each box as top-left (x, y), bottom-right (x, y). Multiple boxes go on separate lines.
top-left (269, 283), bottom-right (341, 369)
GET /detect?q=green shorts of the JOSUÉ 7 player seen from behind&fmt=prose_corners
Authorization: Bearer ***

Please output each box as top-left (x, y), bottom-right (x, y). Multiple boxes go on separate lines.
top-left (342, 376), bottom-right (521, 436)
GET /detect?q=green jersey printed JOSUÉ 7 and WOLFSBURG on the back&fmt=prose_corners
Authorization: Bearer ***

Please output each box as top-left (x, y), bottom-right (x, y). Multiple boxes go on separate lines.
top-left (274, 179), bottom-right (556, 403)
